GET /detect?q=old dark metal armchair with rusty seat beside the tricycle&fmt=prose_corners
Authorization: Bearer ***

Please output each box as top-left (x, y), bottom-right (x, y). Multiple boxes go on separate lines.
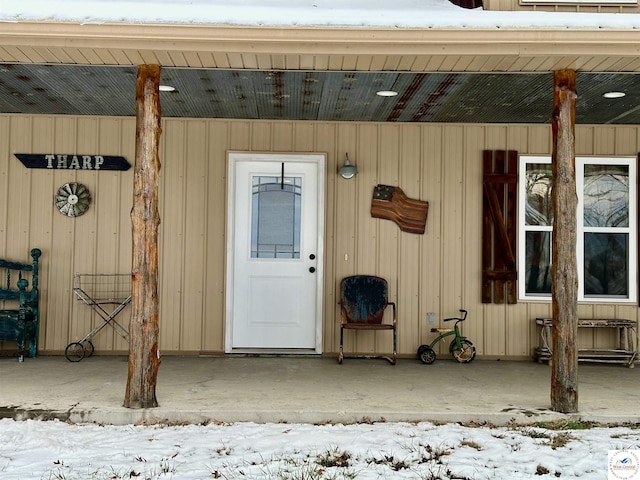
top-left (338, 275), bottom-right (398, 365)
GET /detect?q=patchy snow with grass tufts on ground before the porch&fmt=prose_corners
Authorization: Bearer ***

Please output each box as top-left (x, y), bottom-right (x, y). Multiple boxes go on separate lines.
top-left (0, 419), bottom-right (640, 480)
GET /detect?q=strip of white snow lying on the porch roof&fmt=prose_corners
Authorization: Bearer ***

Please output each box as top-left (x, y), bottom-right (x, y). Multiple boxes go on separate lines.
top-left (0, 0), bottom-right (640, 29)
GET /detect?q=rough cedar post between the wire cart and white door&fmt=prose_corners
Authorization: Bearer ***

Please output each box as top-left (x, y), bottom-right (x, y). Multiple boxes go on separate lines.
top-left (124, 65), bottom-right (161, 408)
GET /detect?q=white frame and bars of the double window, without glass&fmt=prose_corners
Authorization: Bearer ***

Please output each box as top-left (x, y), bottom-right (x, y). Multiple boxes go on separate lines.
top-left (518, 155), bottom-right (638, 303)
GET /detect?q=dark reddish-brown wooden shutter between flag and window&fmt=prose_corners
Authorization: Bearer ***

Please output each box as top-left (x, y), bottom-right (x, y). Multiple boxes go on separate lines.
top-left (482, 150), bottom-right (518, 303)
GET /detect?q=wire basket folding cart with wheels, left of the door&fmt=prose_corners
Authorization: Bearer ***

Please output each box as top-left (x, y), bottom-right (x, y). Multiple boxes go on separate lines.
top-left (64, 273), bottom-right (131, 362)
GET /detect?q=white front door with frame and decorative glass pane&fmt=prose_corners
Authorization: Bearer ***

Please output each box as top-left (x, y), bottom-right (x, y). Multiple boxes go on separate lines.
top-left (225, 152), bottom-right (324, 353)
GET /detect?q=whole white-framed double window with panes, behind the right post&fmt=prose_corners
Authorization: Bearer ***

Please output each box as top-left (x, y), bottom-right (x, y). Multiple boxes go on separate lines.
top-left (518, 156), bottom-right (637, 302)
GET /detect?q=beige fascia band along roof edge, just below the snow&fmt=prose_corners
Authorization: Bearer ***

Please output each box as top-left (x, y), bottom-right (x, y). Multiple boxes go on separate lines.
top-left (0, 22), bottom-right (640, 64)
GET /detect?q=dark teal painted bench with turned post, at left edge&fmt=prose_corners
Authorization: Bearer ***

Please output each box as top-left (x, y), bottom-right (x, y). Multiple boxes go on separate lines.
top-left (0, 248), bottom-right (42, 362)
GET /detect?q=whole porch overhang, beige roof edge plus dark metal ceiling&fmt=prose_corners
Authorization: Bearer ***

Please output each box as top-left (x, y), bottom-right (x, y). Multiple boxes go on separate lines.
top-left (0, 22), bottom-right (640, 124)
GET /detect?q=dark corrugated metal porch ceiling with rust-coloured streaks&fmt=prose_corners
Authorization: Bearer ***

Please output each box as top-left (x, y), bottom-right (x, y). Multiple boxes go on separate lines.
top-left (0, 63), bottom-right (640, 124)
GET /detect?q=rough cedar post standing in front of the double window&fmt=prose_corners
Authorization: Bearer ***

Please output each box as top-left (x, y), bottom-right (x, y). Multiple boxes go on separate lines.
top-left (551, 70), bottom-right (578, 413)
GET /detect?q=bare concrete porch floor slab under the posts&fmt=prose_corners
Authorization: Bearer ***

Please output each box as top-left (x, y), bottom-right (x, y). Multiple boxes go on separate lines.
top-left (0, 356), bottom-right (640, 425)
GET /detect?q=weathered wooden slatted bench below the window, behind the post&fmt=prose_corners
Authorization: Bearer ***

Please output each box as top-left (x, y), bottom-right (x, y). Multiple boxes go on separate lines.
top-left (535, 318), bottom-right (638, 368)
